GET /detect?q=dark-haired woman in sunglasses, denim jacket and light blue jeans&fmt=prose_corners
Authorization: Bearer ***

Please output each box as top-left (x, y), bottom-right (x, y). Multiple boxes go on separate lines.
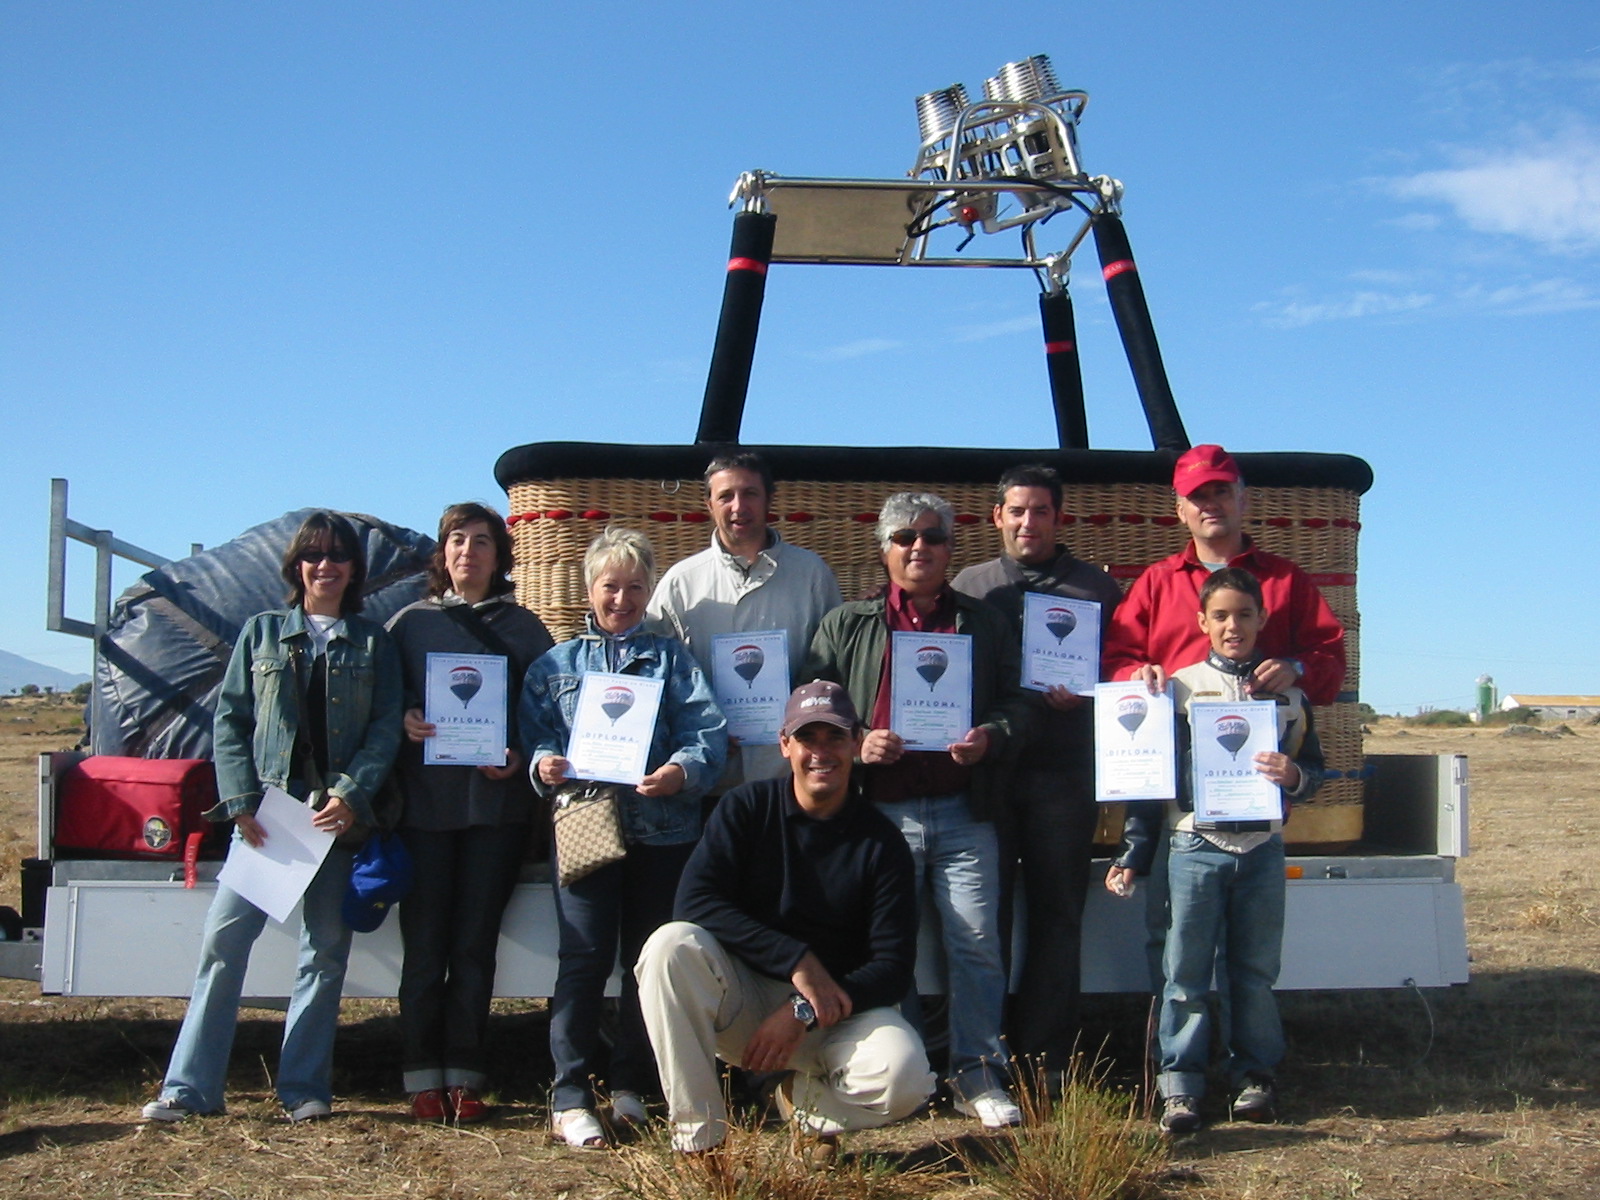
top-left (144, 512), bottom-right (402, 1122)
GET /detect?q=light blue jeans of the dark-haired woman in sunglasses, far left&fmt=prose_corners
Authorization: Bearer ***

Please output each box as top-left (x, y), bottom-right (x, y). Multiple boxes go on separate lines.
top-left (162, 834), bottom-right (352, 1112)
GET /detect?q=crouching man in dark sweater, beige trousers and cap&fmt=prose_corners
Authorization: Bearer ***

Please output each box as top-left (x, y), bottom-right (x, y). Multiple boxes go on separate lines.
top-left (634, 682), bottom-right (934, 1150)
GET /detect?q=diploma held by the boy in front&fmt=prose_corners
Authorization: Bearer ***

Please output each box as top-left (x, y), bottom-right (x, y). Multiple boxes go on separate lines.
top-left (1189, 701), bottom-right (1283, 829)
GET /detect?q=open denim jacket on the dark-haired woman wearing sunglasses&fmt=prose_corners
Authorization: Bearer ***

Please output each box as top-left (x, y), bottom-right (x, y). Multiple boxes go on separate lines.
top-left (206, 606), bottom-right (405, 824)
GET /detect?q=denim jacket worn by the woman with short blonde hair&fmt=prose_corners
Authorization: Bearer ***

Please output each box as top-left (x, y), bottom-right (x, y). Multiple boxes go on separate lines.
top-left (520, 614), bottom-right (728, 846)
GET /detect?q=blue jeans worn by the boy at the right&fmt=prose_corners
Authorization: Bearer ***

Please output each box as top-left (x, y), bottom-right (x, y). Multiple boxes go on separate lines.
top-left (1160, 832), bottom-right (1285, 1096)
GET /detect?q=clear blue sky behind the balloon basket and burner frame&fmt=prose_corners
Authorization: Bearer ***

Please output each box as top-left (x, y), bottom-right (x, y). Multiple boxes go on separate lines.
top-left (0, 0), bottom-right (1600, 710)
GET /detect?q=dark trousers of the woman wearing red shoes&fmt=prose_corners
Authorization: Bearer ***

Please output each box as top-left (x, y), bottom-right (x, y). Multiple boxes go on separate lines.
top-left (400, 824), bottom-right (528, 1093)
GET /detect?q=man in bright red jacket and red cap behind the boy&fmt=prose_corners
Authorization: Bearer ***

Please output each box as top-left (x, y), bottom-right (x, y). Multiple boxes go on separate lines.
top-left (1102, 445), bottom-right (1344, 704)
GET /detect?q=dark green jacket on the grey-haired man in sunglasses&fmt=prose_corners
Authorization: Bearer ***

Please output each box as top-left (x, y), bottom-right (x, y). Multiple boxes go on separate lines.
top-left (798, 592), bottom-right (1034, 821)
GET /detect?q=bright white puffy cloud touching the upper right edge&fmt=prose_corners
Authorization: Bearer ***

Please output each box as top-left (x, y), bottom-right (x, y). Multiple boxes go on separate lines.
top-left (1387, 130), bottom-right (1600, 251)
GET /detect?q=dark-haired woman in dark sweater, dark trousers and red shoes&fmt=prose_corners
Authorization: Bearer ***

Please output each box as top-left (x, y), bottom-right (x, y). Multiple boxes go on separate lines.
top-left (389, 502), bottom-right (554, 1125)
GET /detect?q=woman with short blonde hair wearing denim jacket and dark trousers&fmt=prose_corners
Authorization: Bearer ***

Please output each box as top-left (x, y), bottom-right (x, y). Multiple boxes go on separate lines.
top-left (520, 530), bottom-right (728, 1149)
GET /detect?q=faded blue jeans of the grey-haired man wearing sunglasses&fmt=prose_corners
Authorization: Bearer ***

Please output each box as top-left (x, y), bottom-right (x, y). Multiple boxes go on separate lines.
top-left (878, 794), bottom-right (1010, 1099)
